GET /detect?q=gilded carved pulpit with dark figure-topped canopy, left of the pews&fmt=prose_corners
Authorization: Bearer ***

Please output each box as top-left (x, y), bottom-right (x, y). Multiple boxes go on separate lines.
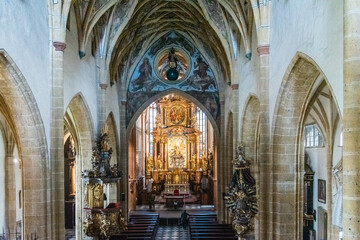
top-left (82, 125), bottom-right (126, 239)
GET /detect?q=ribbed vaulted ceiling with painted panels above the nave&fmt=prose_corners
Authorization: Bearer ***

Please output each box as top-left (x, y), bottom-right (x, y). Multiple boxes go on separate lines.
top-left (72, 0), bottom-right (253, 85)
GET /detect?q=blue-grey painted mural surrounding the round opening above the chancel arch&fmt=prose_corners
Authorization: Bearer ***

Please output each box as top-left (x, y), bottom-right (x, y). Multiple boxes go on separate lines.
top-left (126, 32), bottom-right (220, 126)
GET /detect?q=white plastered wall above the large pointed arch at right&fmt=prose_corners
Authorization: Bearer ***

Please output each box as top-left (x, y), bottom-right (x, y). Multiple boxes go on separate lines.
top-left (269, 0), bottom-right (343, 125)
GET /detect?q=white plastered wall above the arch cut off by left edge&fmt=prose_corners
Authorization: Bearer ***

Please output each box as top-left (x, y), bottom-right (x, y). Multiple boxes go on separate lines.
top-left (0, 0), bottom-right (50, 148)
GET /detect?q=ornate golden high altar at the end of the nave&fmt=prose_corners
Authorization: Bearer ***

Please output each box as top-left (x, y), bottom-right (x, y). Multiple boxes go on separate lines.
top-left (146, 95), bottom-right (201, 186)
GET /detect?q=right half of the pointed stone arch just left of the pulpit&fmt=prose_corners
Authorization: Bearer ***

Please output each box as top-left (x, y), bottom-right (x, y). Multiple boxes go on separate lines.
top-left (64, 93), bottom-right (94, 239)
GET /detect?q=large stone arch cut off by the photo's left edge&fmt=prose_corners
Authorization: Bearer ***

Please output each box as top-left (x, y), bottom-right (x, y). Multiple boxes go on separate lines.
top-left (0, 49), bottom-right (49, 239)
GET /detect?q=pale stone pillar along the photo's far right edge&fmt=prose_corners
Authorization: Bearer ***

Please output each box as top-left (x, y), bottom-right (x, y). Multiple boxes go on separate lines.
top-left (343, 0), bottom-right (360, 240)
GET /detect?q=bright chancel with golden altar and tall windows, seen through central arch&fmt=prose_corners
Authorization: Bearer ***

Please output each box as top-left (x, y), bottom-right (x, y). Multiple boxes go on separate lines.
top-left (128, 91), bottom-right (218, 213)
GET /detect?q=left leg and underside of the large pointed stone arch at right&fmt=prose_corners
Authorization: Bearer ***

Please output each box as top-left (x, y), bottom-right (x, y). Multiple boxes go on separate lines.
top-left (271, 53), bottom-right (330, 239)
